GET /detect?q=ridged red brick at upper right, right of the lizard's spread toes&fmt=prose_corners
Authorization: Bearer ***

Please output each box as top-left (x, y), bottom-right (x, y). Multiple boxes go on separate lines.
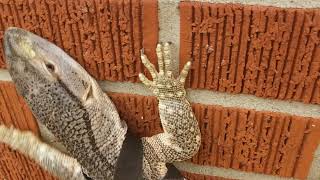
top-left (180, 2), bottom-right (320, 104)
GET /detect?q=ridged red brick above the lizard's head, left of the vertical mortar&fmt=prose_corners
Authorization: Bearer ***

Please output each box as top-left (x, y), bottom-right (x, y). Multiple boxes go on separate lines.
top-left (0, 0), bottom-right (158, 82)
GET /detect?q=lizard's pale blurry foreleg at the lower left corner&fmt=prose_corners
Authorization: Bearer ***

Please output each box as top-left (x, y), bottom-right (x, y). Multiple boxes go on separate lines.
top-left (0, 125), bottom-right (85, 180)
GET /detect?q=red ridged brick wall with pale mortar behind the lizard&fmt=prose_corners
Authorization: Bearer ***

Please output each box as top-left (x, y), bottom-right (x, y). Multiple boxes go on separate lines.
top-left (0, 0), bottom-right (320, 180)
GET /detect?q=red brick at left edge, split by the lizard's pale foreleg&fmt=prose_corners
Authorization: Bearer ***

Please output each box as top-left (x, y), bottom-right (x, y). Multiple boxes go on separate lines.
top-left (0, 82), bottom-right (55, 180)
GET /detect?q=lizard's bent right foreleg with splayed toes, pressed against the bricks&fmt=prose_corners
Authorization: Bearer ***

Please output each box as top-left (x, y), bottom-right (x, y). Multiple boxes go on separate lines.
top-left (139, 43), bottom-right (201, 179)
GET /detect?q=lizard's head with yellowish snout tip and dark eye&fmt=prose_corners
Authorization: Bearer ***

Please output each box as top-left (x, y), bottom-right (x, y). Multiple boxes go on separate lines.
top-left (3, 27), bottom-right (99, 107)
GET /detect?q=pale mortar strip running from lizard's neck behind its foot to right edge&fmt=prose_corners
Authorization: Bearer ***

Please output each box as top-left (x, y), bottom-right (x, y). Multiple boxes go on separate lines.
top-left (99, 81), bottom-right (320, 118)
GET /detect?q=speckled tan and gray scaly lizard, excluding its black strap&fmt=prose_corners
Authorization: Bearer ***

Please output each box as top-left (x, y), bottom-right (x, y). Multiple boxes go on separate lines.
top-left (0, 28), bottom-right (200, 180)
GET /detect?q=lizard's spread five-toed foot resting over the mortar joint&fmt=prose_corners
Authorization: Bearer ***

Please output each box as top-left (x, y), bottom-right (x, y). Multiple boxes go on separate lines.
top-left (139, 43), bottom-right (191, 99)
